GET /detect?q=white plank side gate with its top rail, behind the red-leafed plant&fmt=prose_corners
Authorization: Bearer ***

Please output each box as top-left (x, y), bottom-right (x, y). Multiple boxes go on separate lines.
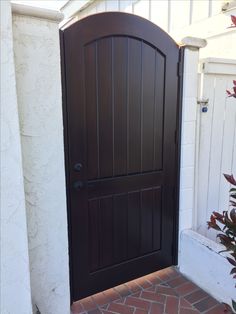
top-left (195, 58), bottom-right (236, 240)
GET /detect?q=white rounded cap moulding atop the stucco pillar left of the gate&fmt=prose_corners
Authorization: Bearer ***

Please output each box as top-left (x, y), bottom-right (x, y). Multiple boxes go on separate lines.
top-left (11, 2), bottom-right (64, 22)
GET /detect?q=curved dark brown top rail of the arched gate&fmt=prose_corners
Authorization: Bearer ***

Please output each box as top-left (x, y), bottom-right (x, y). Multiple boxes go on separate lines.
top-left (63, 12), bottom-right (179, 55)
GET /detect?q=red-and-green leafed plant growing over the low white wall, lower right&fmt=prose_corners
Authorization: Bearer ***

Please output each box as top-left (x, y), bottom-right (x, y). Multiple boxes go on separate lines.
top-left (207, 174), bottom-right (236, 313)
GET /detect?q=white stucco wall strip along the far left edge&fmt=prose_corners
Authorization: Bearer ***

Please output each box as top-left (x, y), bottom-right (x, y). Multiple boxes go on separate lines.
top-left (0, 1), bottom-right (32, 314)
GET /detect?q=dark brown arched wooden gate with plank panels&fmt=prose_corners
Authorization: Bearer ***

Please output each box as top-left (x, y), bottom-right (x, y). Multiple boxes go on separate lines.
top-left (61, 12), bottom-right (182, 300)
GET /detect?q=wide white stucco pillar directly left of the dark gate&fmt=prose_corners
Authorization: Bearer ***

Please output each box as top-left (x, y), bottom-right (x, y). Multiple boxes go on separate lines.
top-left (12, 7), bottom-right (70, 314)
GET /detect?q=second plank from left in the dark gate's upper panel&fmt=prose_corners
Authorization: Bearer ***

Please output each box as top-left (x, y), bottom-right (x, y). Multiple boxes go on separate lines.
top-left (97, 38), bottom-right (113, 177)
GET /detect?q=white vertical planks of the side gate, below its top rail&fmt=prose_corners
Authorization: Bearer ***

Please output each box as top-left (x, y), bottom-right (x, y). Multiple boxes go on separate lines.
top-left (197, 74), bottom-right (236, 240)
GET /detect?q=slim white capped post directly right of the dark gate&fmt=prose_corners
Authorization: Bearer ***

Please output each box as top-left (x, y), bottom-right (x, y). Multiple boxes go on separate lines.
top-left (179, 37), bottom-right (207, 249)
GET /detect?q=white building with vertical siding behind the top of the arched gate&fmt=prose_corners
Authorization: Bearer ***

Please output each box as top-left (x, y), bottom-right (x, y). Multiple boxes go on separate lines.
top-left (61, 0), bottom-right (236, 59)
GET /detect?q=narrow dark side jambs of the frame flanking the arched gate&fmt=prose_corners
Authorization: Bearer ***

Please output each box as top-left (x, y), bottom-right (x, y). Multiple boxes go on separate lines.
top-left (59, 16), bottom-right (185, 304)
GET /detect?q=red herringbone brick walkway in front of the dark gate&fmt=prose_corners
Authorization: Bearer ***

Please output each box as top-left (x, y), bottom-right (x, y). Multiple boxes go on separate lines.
top-left (72, 267), bottom-right (229, 314)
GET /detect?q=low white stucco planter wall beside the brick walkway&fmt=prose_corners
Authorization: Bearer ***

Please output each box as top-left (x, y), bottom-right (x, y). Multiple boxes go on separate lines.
top-left (179, 230), bottom-right (235, 304)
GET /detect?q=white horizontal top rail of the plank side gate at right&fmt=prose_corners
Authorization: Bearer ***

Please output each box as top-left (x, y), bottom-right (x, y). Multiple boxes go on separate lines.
top-left (199, 58), bottom-right (236, 75)
